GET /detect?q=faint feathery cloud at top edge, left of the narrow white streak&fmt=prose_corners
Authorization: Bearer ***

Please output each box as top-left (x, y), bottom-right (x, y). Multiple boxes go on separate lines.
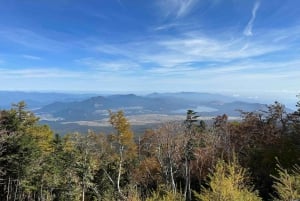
top-left (158, 0), bottom-right (198, 18)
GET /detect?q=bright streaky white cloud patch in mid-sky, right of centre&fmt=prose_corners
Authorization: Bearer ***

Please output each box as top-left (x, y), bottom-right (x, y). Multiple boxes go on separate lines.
top-left (149, 35), bottom-right (282, 64)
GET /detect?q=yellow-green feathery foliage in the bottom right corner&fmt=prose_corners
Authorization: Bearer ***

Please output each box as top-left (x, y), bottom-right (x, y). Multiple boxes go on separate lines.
top-left (273, 165), bottom-right (300, 201)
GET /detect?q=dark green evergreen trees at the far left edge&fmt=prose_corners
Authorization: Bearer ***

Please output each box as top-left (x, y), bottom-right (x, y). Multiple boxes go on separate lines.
top-left (0, 102), bottom-right (42, 200)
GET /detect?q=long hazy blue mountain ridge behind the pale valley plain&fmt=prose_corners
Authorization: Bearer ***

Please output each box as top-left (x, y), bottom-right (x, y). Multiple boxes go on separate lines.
top-left (35, 92), bottom-right (266, 121)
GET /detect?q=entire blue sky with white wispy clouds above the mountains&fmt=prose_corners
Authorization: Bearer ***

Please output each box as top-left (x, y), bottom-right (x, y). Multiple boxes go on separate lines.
top-left (0, 0), bottom-right (300, 106)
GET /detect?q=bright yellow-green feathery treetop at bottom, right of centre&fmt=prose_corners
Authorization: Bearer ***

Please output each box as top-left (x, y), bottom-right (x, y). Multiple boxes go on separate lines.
top-left (195, 160), bottom-right (261, 201)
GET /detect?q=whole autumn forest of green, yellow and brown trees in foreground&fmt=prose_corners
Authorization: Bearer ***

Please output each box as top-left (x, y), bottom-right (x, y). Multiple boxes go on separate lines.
top-left (0, 98), bottom-right (300, 201)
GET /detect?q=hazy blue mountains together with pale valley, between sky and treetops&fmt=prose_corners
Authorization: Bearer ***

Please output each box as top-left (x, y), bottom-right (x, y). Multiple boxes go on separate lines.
top-left (0, 91), bottom-right (276, 134)
